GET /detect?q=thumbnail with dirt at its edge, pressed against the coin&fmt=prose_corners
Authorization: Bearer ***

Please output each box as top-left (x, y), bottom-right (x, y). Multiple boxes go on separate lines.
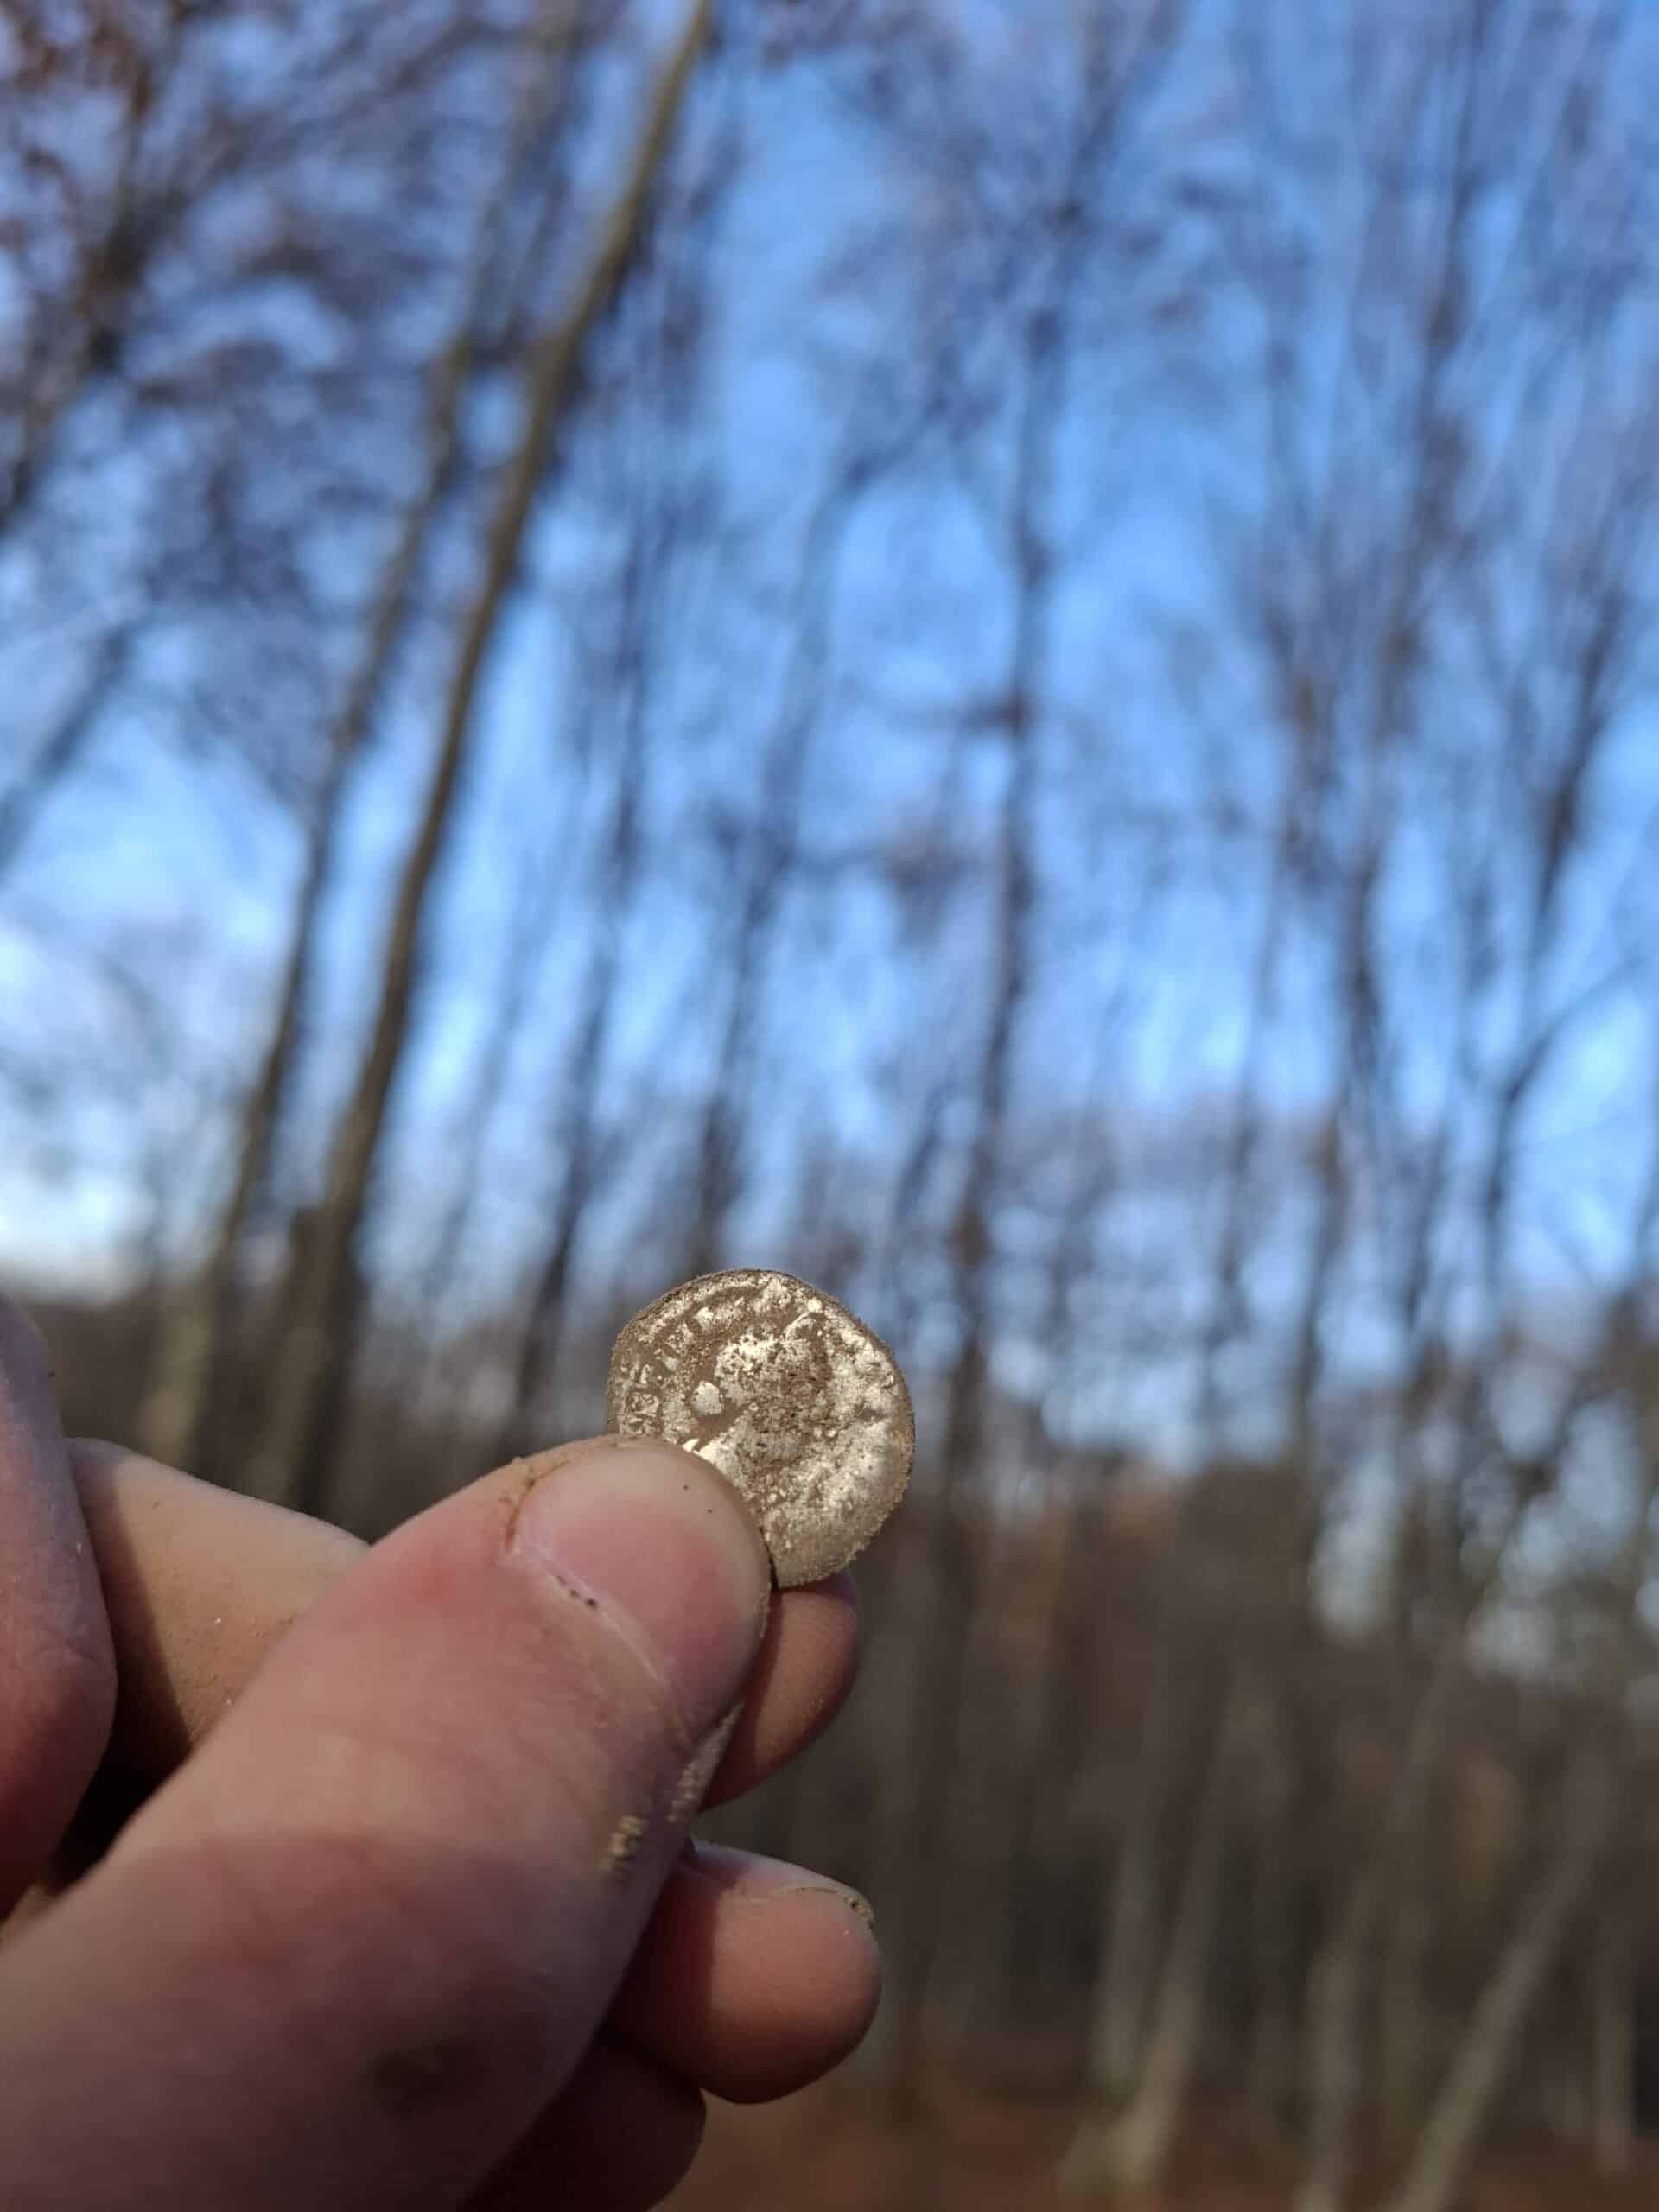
top-left (509, 1438), bottom-right (772, 1743)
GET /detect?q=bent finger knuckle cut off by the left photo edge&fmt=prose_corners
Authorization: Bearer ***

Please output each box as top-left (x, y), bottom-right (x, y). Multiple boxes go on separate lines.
top-left (0, 1296), bottom-right (115, 1918)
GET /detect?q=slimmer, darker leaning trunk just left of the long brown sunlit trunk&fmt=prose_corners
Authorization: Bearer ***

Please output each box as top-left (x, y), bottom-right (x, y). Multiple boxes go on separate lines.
top-left (139, 0), bottom-right (575, 1469)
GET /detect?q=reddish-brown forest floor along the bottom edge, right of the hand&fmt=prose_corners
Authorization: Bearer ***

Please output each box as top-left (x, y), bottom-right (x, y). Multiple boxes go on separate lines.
top-left (671, 2082), bottom-right (1659, 2212)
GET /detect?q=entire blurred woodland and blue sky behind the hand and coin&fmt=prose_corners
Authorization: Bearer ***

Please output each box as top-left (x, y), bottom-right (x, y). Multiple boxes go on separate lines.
top-left (0, 0), bottom-right (1659, 2212)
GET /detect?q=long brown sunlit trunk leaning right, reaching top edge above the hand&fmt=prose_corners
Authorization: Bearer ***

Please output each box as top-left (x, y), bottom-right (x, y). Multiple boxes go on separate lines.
top-left (250, 0), bottom-right (712, 1509)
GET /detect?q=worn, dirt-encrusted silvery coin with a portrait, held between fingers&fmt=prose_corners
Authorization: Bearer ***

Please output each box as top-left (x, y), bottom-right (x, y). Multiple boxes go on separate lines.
top-left (608, 1268), bottom-right (916, 1591)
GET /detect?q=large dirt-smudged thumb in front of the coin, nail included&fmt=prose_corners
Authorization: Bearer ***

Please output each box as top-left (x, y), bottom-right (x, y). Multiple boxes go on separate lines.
top-left (0, 1438), bottom-right (770, 2212)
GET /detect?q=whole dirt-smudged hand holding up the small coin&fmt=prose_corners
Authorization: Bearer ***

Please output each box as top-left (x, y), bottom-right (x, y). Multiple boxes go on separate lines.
top-left (0, 1300), bottom-right (878, 2212)
